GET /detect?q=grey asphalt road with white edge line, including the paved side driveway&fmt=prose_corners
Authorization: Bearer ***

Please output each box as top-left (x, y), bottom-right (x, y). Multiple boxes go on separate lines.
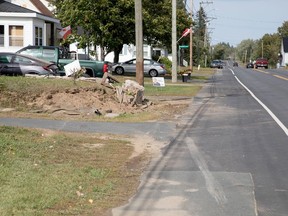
top-left (0, 65), bottom-right (288, 216)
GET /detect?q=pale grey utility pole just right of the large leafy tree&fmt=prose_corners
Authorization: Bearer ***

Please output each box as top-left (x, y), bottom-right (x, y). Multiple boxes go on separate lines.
top-left (171, 0), bottom-right (177, 83)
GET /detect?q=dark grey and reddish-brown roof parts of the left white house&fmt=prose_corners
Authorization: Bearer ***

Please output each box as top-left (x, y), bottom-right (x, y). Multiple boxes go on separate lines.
top-left (0, 0), bottom-right (53, 17)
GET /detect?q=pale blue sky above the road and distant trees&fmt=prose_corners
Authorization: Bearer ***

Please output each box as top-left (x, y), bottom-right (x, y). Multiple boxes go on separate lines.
top-left (187, 0), bottom-right (288, 46)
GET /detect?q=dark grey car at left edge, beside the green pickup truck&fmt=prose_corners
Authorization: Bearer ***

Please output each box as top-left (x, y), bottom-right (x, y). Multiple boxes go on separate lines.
top-left (0, 52), bottom-right (59, 76)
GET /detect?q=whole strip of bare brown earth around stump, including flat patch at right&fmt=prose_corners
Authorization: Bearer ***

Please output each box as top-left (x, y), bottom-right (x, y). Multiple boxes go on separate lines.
top-left (0, 79), bottom-right (191, 120)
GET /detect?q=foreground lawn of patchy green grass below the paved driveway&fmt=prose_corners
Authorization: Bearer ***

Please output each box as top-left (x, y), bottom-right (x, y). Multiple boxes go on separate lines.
top-left (0, 127), bottom-right (144, 216)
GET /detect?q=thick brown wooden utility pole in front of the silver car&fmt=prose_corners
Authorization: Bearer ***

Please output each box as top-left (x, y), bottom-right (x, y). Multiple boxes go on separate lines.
top-left (135, 0), bottom-right (144, 86)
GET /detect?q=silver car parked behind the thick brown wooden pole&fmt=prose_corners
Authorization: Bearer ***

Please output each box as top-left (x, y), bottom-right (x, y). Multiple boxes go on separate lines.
top-left (112, 59), bottom-right (167, 77)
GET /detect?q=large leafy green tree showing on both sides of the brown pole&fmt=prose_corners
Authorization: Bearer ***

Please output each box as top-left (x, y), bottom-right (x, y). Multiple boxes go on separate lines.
top-left (52, 0), bottom-right (189, 62)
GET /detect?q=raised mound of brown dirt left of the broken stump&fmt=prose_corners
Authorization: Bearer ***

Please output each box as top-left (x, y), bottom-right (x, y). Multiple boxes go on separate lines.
top-left (28, 85), bottom-right (152, 117)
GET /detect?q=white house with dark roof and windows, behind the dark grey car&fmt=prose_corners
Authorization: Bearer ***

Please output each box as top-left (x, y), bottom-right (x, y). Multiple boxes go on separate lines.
top-left (0, 0), bottom-right (61, 52)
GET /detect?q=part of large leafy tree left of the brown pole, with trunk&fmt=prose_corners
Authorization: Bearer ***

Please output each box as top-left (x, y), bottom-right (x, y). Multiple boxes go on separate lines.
top-left (52, 0), bottom-right (135, 61)
